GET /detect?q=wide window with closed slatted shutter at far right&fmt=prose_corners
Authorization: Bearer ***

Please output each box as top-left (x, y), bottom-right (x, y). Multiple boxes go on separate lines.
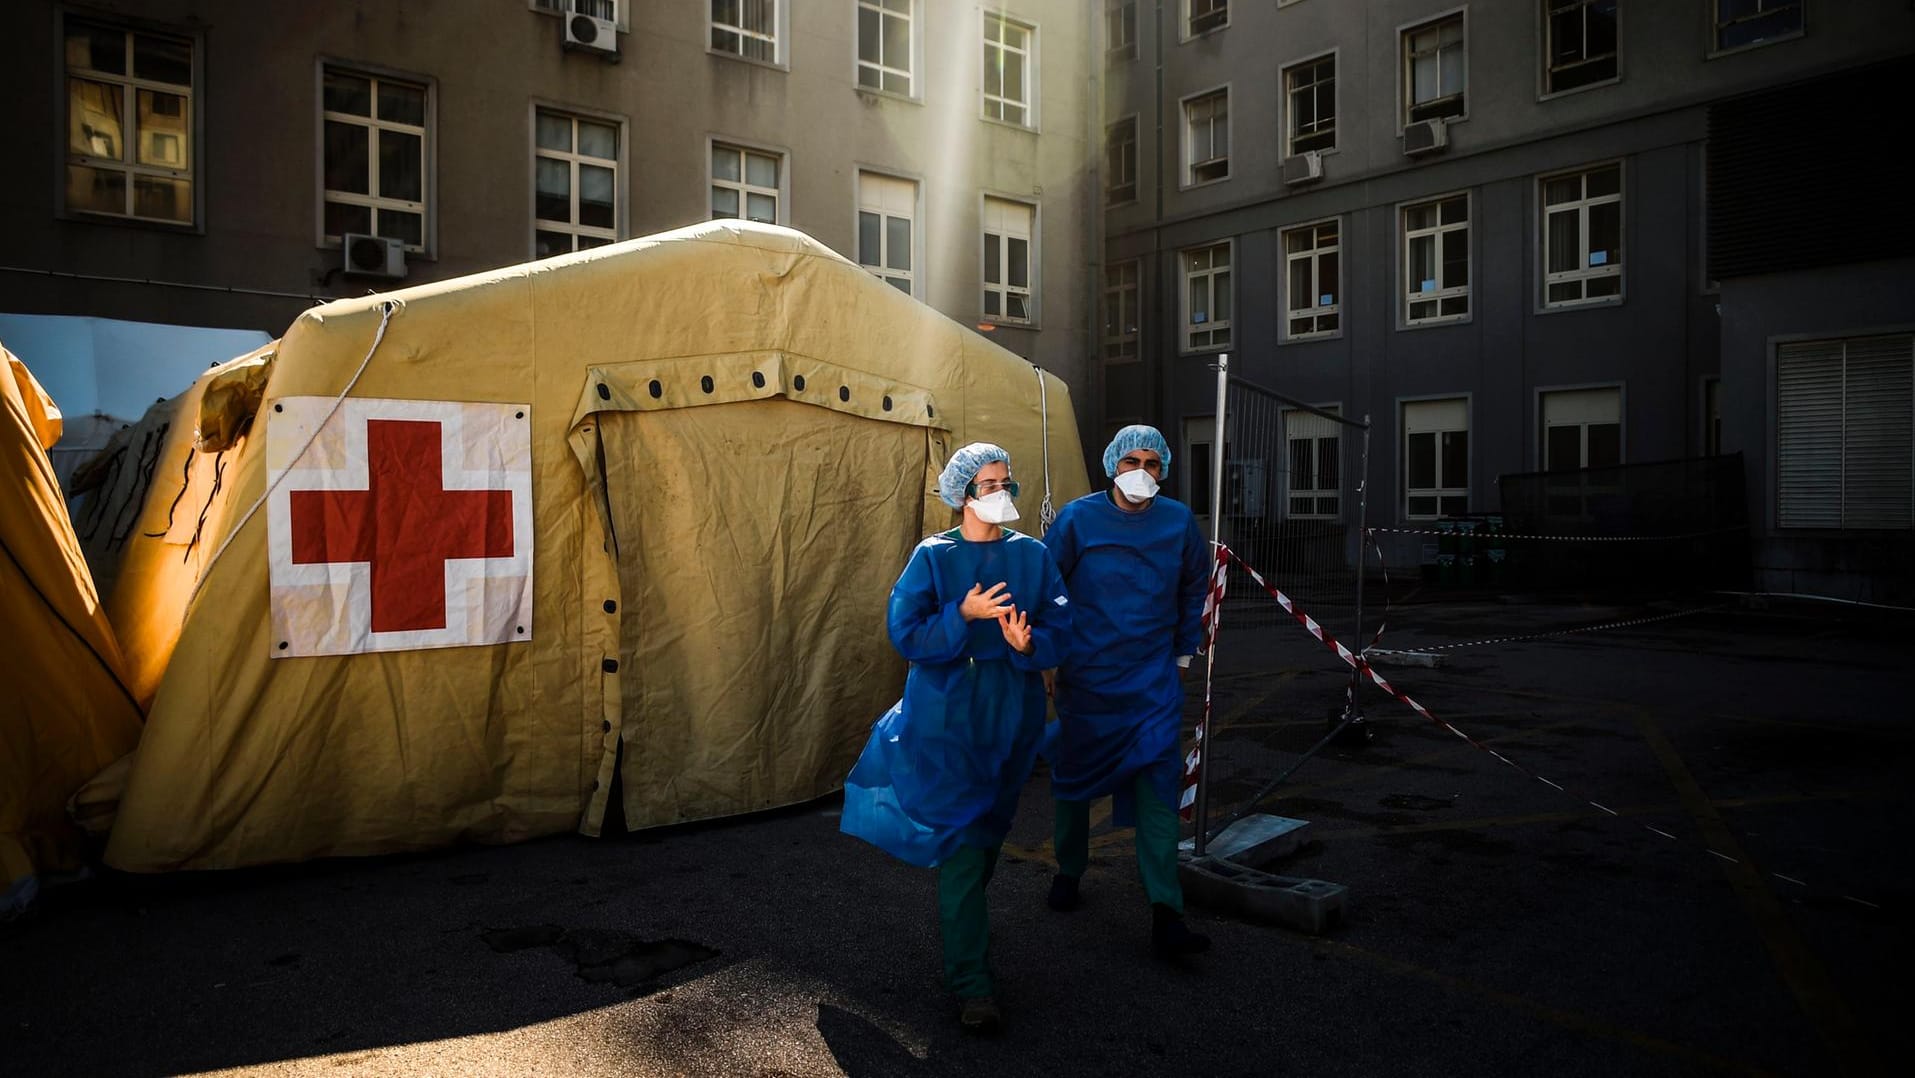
top-left (1775, 333), bottom-right (1915, 528)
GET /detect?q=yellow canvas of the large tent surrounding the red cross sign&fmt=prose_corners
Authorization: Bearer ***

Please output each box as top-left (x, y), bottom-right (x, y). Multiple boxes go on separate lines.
top-left (107, 222), bottom-right (1088, 871)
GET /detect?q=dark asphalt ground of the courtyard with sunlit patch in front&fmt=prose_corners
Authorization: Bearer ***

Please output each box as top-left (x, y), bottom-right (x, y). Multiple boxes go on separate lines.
top-left (0, 597), bottom-right (1915, 1078)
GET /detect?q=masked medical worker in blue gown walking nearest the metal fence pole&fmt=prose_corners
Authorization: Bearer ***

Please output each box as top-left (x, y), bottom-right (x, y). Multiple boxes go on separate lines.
top-left (1044, 425), bottom-right (1212, 955)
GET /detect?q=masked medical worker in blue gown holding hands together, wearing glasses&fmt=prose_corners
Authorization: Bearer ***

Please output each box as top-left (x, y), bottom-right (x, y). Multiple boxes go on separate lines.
top-left (843, 442), bottom-right (1070, 1032)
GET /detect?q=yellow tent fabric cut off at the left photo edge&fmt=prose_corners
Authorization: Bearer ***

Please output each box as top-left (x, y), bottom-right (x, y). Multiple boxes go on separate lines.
top-left (0, 348), bottom-right (140, 913)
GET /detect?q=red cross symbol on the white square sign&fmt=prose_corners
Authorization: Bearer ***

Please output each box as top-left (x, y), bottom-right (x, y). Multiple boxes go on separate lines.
top-left (291, 419), bottom-right (513, 632)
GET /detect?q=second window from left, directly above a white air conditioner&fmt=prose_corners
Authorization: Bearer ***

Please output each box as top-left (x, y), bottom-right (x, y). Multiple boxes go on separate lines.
top-left (320, 65), bottom-right (431, 253)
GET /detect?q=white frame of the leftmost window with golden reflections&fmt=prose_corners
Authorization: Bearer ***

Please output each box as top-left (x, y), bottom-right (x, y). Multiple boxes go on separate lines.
top-left (54, 8), bottom-right (207, 232)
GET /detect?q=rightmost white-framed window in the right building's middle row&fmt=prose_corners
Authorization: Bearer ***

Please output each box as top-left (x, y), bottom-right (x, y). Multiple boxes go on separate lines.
top-left (1540, 165), bottom-right (1622, 306)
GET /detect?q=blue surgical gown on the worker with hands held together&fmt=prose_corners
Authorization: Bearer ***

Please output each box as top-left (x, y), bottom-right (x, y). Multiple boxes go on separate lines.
top-left (841, 530), bottom-right (1070, 865)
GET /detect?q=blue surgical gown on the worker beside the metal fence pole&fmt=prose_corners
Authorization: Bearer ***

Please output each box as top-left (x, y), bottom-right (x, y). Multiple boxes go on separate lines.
top-left (1044, 492), bottom-right (1212, 825)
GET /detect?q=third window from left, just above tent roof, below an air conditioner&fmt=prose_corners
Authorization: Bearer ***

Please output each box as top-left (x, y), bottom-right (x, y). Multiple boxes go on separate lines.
top-left (532, 109), bottom-right (620, 258)
